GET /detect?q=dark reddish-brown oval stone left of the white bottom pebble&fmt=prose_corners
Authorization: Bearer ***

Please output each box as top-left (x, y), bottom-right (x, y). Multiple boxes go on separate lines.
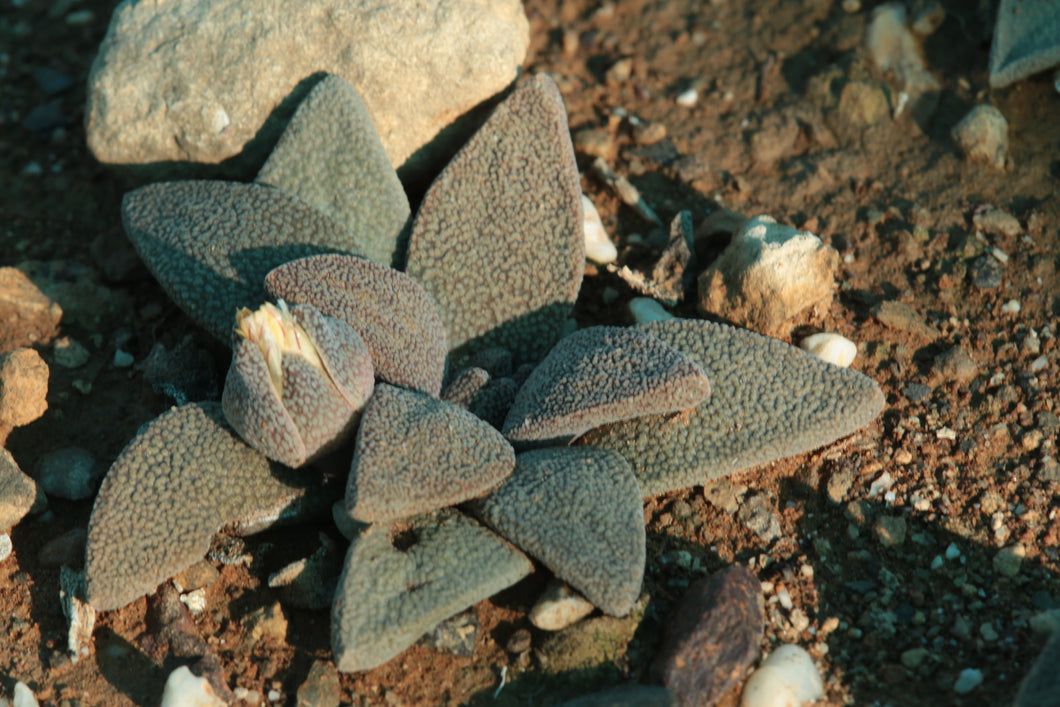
top-left (654, 565), bottom-right (764, 706)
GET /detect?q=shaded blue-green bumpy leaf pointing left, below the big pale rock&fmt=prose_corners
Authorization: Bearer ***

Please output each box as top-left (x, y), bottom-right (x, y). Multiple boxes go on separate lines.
top-left (122, 181), bottom-right (363, 343)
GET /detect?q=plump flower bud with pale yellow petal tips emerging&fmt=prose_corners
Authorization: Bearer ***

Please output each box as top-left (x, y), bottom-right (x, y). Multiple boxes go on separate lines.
top-left (220, 300), bottom-right (375, 466)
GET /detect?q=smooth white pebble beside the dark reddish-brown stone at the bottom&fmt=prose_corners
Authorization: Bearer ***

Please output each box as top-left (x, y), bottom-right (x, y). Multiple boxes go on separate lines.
top-left (740, 643), bottom-right (825, 707)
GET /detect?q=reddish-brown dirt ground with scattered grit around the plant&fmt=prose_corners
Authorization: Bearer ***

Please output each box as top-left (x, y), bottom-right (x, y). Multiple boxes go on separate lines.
top-left (0, 0), bottom-right (1060, 706)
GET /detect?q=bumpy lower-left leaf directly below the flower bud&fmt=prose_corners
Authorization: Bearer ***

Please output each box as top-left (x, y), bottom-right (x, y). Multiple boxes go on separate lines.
top-left (85, 403), bottom-right (331, 611)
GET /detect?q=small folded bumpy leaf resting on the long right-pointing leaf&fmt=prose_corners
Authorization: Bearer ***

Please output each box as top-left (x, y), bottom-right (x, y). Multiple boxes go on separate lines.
top-left (501, 326), bottom-right (710, 444)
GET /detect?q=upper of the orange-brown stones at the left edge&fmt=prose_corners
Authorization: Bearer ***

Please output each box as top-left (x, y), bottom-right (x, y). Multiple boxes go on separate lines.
top-left (0, 267), bottom-right (63, 353)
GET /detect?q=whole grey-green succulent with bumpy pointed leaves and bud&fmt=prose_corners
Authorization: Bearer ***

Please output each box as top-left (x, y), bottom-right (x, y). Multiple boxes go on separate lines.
top-left (86, 70), bottom-right (883, 671)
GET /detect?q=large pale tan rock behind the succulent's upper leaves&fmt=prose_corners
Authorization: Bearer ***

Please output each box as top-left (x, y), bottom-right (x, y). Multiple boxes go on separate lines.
top-left (85, 0), bottom-right (529, 180)
